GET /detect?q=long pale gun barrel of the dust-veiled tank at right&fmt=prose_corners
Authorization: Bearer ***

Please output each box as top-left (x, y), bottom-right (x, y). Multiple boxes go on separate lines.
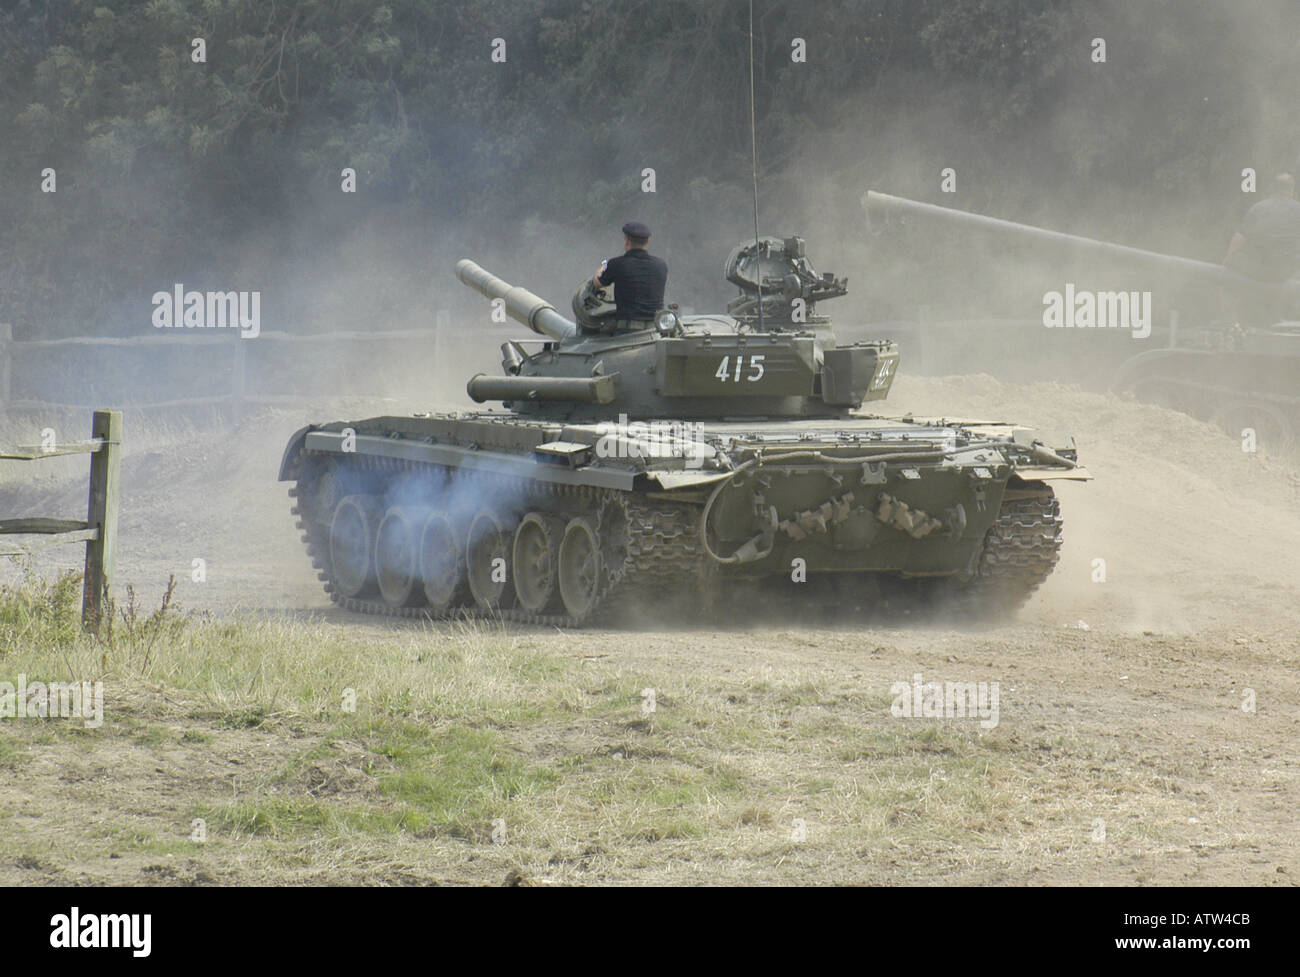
top-left (863, 190), bottom-right (1284, 309)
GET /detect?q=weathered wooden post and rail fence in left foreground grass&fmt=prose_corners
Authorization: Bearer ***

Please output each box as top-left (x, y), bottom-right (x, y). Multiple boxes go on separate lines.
top-left (0, 411), bottom-right (122, 626)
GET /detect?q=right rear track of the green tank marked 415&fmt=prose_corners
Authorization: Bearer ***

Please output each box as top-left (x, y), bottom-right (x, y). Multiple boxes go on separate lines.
top-left (945, 487), bottom-right (1063, 617)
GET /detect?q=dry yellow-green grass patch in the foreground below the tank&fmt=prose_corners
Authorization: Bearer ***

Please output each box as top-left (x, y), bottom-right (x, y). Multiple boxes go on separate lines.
top-left (0, 571), bottom-right (1251, 882)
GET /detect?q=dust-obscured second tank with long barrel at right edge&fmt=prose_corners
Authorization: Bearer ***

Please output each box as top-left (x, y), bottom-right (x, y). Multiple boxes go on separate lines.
top-left (863, 191), bottom-right (1300, 453)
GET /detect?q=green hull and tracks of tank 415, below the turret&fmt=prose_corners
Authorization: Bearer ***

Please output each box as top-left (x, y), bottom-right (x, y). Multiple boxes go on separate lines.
top-left (280, 412), bottom-right (1088, 626)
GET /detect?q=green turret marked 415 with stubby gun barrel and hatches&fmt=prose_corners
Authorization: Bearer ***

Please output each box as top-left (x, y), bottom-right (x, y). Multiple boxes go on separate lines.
top-left (456, 238), bottom-right (898, 420)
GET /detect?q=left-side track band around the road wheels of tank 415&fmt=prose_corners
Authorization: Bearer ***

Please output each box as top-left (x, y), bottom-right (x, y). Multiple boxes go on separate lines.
top-left (289, 452), bottom-right (706, 628)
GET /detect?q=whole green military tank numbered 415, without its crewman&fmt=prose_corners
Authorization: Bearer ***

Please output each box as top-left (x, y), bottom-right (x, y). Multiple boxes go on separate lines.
top-left (280, 238), bottom-right (1089, 626)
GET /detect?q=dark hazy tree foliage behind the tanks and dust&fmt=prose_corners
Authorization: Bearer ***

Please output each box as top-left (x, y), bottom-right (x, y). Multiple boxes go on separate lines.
top-left (0, 0), bottom-right (1300, 334)
